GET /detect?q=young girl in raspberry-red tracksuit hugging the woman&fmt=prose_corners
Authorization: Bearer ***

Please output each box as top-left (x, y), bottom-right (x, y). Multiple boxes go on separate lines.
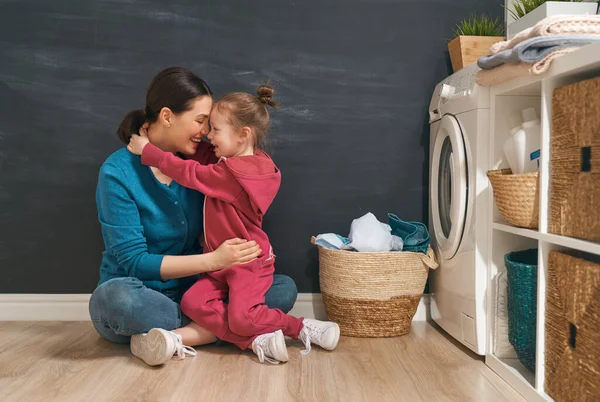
top-left (128, 85), bottom-right (340, 364)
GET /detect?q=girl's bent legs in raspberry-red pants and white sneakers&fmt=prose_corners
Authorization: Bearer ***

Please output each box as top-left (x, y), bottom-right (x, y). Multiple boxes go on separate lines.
top-left (180, 260), bottom-right (339, 363)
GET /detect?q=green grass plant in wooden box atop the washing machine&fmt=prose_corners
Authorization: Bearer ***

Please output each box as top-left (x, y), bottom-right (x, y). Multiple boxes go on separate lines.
top-left (448, 14), bottom-right (504, 72)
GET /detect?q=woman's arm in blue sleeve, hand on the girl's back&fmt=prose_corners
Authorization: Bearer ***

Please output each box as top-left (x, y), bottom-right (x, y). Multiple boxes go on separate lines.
top-left (96, 164), bottom-right (260, 280)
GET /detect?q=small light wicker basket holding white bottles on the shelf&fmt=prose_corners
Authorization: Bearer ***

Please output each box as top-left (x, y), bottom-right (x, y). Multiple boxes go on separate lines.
top-left (487, 169), bottom-right (540, 229)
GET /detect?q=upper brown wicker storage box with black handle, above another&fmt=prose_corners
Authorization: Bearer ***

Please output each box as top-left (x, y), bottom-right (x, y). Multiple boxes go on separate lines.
top-left (549, 77), bottom-right (600, 242)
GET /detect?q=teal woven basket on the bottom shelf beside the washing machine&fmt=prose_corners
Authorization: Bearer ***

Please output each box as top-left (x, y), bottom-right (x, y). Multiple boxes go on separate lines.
top-left (504, 248), bottom-right (538, 371)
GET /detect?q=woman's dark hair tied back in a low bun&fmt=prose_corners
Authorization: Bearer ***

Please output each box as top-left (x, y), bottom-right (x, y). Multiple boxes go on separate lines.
top-left (117, 67), bottom-right (212, 144)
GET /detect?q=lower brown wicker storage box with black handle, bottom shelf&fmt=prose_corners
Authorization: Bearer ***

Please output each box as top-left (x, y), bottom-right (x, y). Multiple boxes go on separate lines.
top-left (545, 251), bottom-right (600, 402)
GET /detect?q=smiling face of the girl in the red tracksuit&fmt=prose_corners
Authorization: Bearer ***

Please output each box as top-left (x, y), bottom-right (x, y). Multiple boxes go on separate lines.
top-left (208, 107), bottom-right (247, 158)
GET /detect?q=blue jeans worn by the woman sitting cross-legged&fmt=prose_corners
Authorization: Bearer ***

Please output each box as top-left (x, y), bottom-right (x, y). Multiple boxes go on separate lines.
top-left (90, 275), bottom-right (298, 343)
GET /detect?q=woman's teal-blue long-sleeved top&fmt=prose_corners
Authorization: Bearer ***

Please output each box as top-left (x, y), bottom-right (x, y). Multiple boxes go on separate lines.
top-left (96, 148), bottom-right (204, 292)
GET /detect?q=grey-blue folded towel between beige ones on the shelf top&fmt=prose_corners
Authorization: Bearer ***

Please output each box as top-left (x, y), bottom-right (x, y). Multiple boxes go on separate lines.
top-left (477, 35), bottom-right (600, 70)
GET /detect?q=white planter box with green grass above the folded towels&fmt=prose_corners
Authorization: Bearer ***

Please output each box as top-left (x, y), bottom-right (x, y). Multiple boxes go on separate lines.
top-left (504, 0), bottom-right (598, 39)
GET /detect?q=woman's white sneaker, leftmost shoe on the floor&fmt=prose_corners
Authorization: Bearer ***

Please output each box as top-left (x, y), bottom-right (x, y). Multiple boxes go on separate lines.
top-left (130, 328), bottom-right (197, 366)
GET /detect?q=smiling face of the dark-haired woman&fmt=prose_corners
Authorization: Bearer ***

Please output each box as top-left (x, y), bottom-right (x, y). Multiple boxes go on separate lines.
top-left (163, 96), bottom-right (212, 156)
